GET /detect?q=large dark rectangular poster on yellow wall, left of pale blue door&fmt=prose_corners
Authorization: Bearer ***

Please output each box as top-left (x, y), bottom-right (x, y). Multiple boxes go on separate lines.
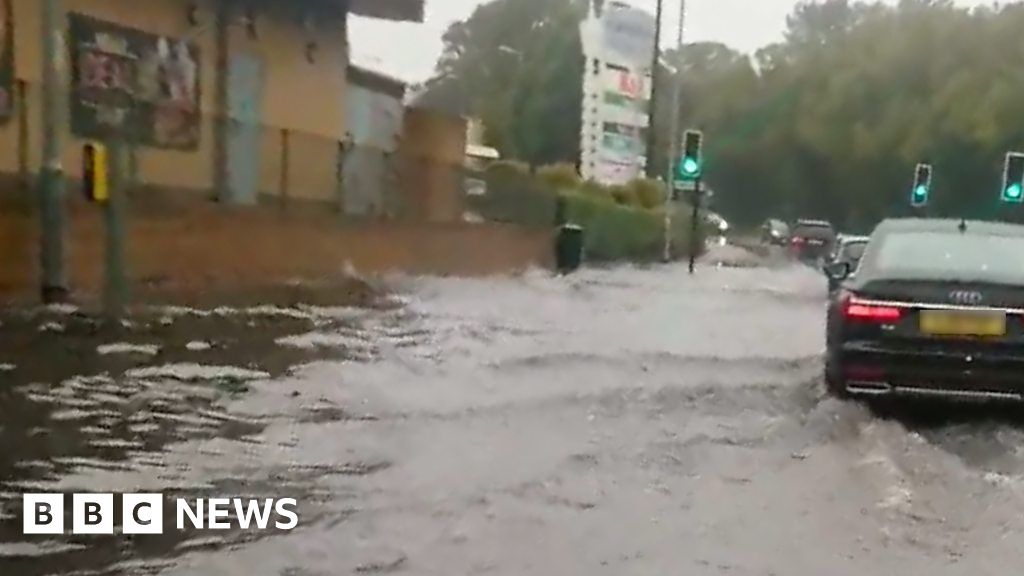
top-left (69, 14), bottom-right (202, 150)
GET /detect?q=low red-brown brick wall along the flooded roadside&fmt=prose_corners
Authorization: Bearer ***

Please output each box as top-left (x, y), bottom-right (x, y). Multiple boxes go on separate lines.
top-left (0, 193), bottom-right (552, 301)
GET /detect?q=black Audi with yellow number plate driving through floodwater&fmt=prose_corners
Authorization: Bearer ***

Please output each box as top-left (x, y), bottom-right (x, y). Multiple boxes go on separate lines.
top-left (825, 219), bottom-right (1024, 400)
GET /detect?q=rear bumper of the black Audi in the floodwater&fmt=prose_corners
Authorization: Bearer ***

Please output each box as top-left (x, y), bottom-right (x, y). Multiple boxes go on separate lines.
top-left (838, 342), bottom-right (1024, 401)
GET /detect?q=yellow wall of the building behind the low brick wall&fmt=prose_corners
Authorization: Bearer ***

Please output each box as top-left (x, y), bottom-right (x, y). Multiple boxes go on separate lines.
top-left (0, 0), bottom-right (346, 200)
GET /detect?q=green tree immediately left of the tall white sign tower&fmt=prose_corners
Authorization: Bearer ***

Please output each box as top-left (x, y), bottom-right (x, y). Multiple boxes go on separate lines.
top-left (409, 0), bottom-right (586, 164)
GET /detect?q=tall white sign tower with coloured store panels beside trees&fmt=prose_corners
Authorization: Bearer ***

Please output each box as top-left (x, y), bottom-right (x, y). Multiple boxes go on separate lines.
top-left (580, 1), bottom-right (656, 184)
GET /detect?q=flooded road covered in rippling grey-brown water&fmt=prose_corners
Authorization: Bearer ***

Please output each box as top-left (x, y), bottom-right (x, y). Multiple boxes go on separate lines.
top-left (6, 248), bottom-right (1024, 576)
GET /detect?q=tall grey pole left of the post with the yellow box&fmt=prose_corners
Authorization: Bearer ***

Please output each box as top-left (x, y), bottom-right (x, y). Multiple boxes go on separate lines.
top-left (39, 0), bottom-right (68, 303)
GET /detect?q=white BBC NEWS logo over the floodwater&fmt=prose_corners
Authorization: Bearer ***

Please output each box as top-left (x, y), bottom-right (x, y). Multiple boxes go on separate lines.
top-left (22, 494), bottom-right (299, 534)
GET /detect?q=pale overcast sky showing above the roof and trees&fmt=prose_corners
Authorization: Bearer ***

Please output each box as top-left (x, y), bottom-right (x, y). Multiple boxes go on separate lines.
top-left (351, 0), bottom-right (987, 82)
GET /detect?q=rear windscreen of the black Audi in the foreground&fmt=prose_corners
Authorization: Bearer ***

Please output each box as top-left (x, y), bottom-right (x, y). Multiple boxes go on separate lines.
top-left (870, 232), bottom-right (1024, 285)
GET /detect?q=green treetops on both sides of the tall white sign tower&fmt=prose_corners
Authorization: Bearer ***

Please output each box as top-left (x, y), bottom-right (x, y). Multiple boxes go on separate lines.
top-left (417, 0), bottom-right (1024, 230)
